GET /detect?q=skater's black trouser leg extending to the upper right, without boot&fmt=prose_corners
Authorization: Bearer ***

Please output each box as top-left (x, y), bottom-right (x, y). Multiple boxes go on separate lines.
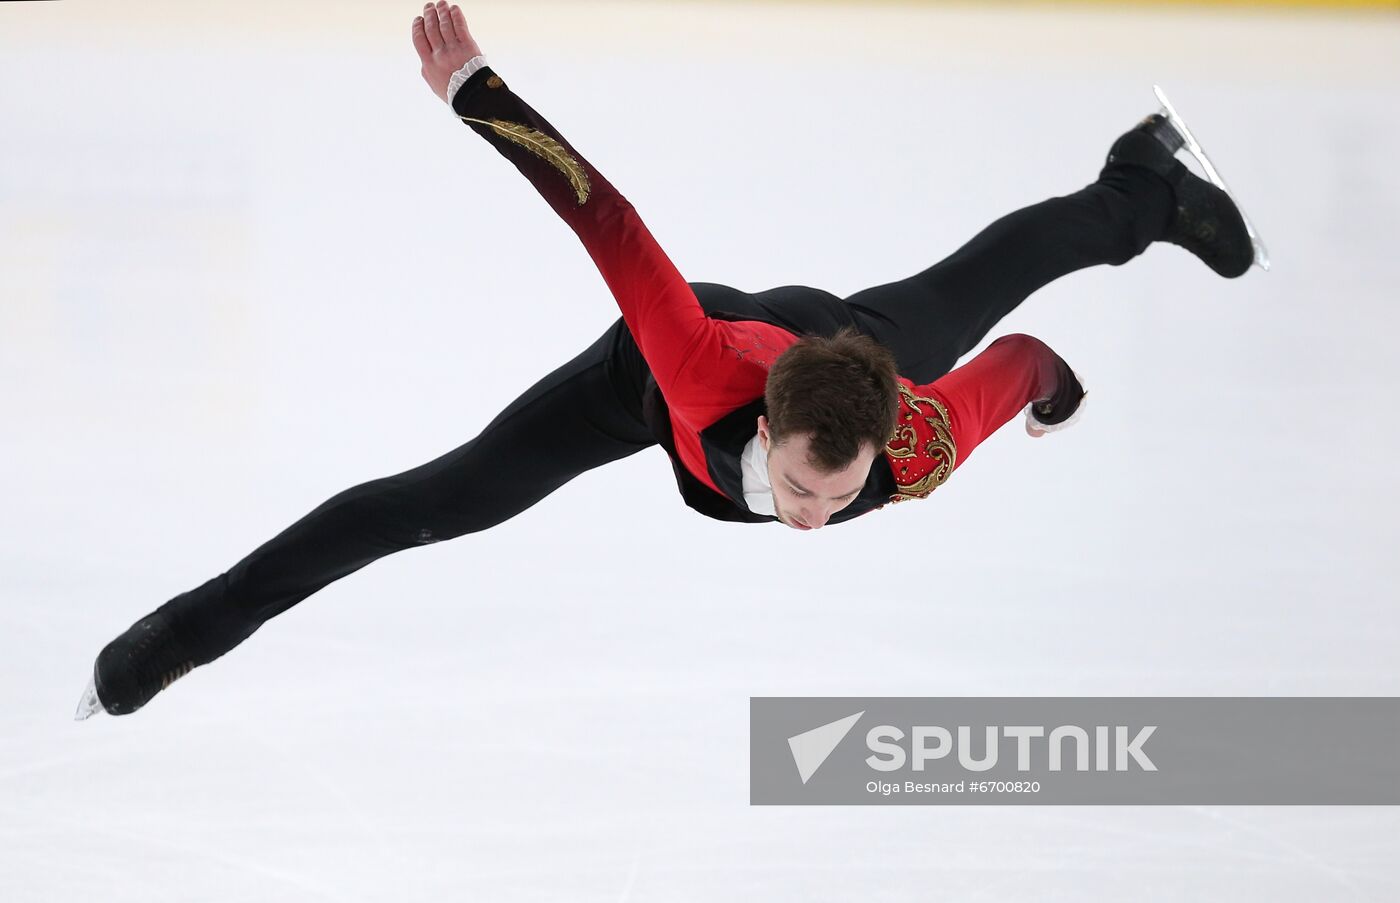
top-left (847, 165), bottom-right (1175, 382)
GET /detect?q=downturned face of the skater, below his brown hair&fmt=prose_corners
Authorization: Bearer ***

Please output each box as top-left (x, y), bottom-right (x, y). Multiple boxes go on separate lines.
top-left (759, 417), bottom-right (875, 529)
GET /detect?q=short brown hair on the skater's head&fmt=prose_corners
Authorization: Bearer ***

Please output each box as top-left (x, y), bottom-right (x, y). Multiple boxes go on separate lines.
top-left (763, 328), bottom-right (899, 473)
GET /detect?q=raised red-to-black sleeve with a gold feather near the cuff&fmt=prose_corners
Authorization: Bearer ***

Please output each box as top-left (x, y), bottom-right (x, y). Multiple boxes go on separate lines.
top-left (452, 67), bottom-right (794, 430)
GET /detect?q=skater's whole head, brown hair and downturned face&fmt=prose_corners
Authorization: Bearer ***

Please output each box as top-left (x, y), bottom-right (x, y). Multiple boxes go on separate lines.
top-left (759, 329), bottom-right (899, 529)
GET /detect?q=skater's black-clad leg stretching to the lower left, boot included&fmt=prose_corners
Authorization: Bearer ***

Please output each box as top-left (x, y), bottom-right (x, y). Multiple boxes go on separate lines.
top-left (88, 321), bottom-right (654, 714)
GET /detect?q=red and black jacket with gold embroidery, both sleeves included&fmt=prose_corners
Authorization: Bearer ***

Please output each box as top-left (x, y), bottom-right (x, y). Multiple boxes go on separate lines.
top-left (454, 67), bottom-right (1082, 524)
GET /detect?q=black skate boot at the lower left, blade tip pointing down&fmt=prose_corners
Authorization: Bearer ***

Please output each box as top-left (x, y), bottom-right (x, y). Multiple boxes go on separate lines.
top-left (76, 612), bottom-right (196, 721)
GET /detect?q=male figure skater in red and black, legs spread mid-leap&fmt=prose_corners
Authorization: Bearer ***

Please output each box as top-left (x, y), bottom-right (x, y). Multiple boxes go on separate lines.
top-left (78, 3), bottom-right (1264, 717)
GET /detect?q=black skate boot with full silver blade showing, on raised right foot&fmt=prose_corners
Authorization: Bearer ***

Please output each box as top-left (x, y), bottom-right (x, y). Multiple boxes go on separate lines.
top-left (1107, 88), bottom-right (1268, 279)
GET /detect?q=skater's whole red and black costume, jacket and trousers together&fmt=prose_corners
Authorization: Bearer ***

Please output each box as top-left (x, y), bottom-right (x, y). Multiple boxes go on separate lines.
top-left (147, 67), bottom-right (1175, 665)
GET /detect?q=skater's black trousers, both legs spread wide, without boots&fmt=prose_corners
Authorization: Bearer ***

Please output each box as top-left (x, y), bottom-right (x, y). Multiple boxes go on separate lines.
top-left (162, 167), bottom-right (1175, 664)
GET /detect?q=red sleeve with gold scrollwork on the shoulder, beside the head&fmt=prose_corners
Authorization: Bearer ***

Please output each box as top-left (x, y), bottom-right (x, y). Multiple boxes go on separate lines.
top-left (885, 335), bottom-right (1084, 500)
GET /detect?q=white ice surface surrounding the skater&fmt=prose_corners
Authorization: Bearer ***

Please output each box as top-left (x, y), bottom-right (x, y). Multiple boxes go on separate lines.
top-left (0, 0), bottom-right (1400, 903)
